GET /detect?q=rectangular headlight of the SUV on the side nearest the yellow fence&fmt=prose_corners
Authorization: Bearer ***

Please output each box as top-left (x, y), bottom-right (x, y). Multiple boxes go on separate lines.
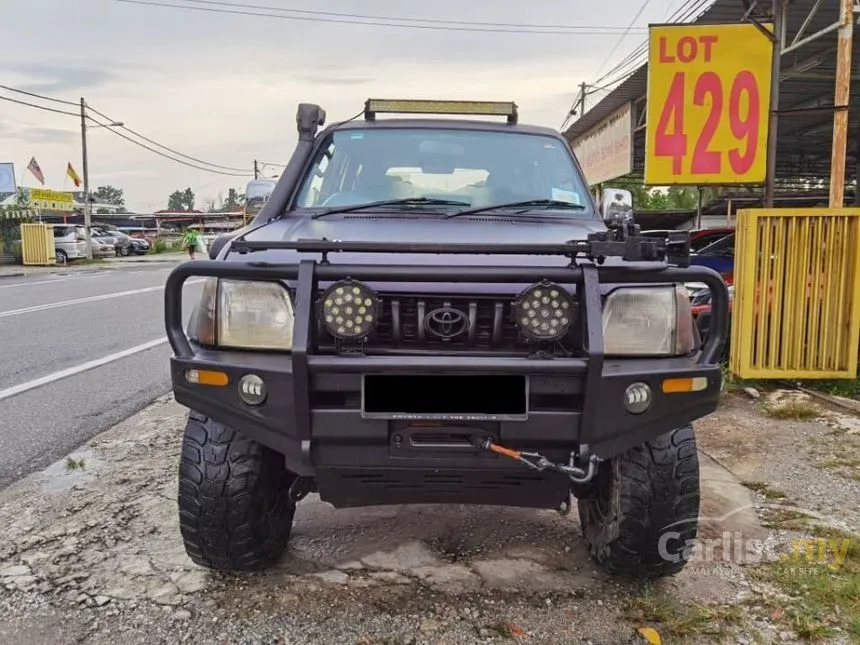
top-left (603, 285), bottom-right (698, 356)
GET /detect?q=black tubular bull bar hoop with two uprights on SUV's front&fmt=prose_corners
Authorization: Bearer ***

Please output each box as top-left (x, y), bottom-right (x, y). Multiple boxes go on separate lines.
top-left (164, 256), bottom-right (729, 464)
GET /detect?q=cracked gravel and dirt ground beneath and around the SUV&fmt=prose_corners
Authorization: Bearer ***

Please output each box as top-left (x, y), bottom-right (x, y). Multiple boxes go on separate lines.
top-left (0, 390), bottom-right (858, 645)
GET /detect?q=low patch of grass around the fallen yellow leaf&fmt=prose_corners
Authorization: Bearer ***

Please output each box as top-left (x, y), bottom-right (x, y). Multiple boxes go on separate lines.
top-left (625, 586), bottom-right (743, 643)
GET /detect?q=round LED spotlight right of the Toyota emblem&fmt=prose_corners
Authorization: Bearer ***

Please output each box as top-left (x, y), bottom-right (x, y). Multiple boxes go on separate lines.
top-left (513, 281), bottom-right (574, 341)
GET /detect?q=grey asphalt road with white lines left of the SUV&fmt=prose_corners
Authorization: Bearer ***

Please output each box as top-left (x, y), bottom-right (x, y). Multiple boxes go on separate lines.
top-left (0, 264), bottom-right (200, 488)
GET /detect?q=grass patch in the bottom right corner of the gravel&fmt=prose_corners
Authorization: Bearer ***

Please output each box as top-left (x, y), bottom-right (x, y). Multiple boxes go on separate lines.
top-left (751, 527), bottom-right (860, 642)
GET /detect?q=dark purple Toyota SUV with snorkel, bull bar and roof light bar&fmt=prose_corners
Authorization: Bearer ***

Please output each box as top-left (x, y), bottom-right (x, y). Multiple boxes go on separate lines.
top-left (165, 100), bottom-right (728, 577)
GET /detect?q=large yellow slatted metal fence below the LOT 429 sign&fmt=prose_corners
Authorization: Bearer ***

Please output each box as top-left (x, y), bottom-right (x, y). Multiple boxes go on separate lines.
top-left (730, 208), bottom-right (860, 379)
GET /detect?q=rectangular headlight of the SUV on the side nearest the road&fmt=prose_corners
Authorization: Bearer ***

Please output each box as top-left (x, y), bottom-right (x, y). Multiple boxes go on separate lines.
top-left (196, 278), bottom-right (295, 350)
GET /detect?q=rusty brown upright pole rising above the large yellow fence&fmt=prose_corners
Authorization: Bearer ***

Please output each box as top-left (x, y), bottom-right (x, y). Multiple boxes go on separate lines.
top-left (830, 0), bottom-right (854, 208)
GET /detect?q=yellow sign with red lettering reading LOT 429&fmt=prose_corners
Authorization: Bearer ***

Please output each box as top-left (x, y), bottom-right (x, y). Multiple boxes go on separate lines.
top-left (645, 23), bottom-right (774, 186)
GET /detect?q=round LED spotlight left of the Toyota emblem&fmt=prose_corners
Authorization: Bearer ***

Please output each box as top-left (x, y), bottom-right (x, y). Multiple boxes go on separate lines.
top-left (320, 280), bottom-right (379, 340)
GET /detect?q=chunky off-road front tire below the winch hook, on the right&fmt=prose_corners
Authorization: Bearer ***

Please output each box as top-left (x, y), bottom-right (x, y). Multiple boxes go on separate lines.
top-left (578, 426), bottom-right (699, 579)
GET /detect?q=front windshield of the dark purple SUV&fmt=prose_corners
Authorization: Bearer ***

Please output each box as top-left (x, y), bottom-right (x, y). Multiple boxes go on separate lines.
top-left (296, 128), bottom-right (594, 218)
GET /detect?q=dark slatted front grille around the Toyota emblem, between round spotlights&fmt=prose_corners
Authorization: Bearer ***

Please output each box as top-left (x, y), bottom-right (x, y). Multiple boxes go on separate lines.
top-left (320, 294), bottom-right (572, 352)
